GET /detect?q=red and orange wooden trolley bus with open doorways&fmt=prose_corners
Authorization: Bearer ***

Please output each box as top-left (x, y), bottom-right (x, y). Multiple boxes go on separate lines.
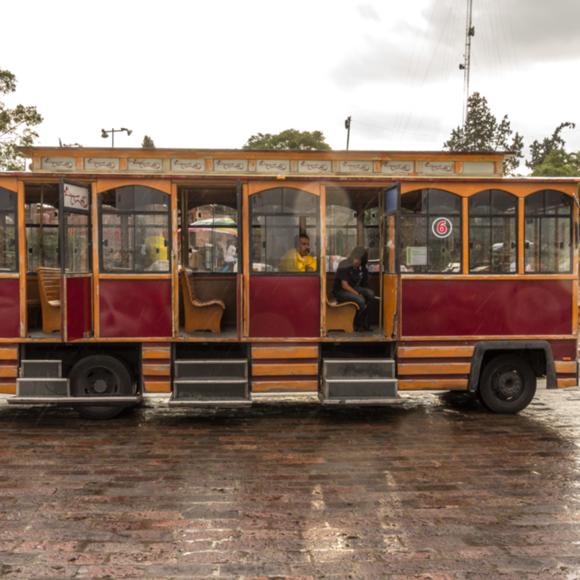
top-left (0, 147), bottom-right (578, 418)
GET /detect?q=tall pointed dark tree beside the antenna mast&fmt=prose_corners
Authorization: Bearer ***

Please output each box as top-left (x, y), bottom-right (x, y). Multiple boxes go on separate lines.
top-left (443, 93), bottom-right (524, 175)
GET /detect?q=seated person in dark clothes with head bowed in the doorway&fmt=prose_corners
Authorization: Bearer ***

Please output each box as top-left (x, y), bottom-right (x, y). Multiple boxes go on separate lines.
top-left (332, 246), bottom-right (375, 331)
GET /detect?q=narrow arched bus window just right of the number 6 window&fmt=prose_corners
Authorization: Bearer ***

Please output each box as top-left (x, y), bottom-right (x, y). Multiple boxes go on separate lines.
top-left (469, 189), bottom-right (518, 274)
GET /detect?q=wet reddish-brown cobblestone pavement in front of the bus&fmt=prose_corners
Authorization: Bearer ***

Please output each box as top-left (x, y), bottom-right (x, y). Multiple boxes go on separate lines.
top-left (0, 389), bottom-right (580, 580)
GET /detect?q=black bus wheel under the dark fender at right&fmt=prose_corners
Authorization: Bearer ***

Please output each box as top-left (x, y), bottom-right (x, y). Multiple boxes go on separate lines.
top-left (479, 354), bottom-right (536, 414)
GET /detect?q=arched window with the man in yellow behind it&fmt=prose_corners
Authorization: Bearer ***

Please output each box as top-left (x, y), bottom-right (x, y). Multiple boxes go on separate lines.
top-left (250, 188), bottom-right (319, 273)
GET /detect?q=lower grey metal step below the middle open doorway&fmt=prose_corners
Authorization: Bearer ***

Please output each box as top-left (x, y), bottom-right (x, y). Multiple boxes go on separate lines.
top-left (172, 379), bottom-right (250, 402)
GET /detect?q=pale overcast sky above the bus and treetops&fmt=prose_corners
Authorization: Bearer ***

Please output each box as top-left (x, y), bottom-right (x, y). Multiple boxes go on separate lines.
top-left (0, 0), bottom-right (580, 159)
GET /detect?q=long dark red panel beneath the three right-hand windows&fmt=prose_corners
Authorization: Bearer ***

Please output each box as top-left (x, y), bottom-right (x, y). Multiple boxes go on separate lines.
top-left (402, 279), bottom-right (576, 336)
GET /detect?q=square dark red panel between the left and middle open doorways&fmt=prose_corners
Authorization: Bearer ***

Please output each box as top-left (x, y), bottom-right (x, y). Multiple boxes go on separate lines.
top-left (99, 279), bottom-right (171, 338)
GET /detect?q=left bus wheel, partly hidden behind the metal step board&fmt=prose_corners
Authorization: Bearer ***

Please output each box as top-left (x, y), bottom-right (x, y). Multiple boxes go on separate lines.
top-left (69, 355), bottom-right (133, 419)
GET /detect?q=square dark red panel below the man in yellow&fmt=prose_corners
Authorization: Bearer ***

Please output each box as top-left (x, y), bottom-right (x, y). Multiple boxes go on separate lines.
top-left (250, 275), bottom-right (320, 338)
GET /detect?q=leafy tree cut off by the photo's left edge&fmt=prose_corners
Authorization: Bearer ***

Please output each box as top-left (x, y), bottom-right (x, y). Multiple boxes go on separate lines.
top-left (0, 69), bottom-right (42, 171)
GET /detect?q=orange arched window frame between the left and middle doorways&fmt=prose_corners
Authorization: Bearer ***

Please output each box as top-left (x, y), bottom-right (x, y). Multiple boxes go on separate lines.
top-left (97, 183), bottom-right (173, 277)
